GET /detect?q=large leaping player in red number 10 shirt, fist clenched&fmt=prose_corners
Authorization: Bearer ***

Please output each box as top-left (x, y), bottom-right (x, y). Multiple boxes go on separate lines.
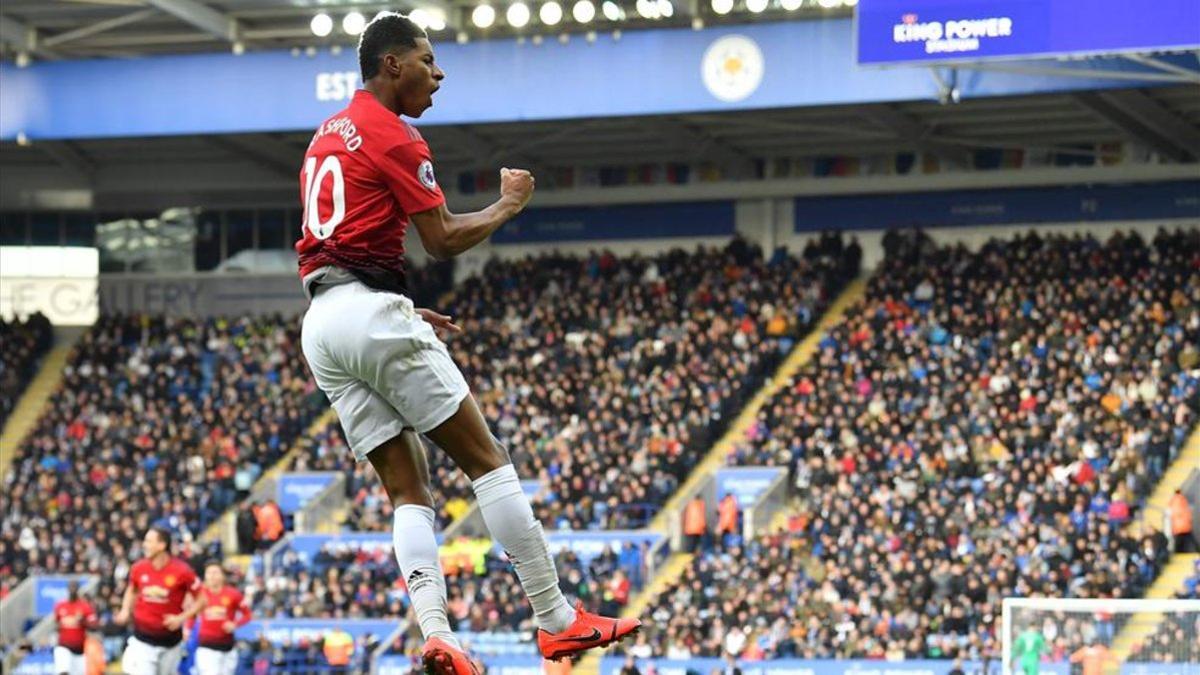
top-left (296, 13), bottom-right (641, 675)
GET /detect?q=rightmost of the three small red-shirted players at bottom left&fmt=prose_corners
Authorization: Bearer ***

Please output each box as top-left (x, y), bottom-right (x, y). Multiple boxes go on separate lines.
top-left (196, 562), bottom-right (252, 675)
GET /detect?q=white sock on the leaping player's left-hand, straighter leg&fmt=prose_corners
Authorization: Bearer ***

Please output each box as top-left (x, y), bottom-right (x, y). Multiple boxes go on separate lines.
top-left (391, 504), bottom-right (461, 649)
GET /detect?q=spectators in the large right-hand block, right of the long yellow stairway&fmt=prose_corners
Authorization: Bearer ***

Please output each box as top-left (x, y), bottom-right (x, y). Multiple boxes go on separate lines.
top-left (633, 229), bottom-right (1200, 657)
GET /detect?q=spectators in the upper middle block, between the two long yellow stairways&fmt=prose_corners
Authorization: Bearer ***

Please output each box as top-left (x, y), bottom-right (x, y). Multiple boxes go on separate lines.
top-left (291, 235), bottom-right (862, 530)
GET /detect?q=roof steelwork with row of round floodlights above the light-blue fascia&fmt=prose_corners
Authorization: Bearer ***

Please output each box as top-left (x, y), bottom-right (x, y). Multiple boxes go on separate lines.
top-left (0, 0), bottom-right (850, 59)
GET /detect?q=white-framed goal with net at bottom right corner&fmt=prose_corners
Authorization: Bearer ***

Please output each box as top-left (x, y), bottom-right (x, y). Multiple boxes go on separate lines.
top-left (1001, 598), bottom-right (1200, 675)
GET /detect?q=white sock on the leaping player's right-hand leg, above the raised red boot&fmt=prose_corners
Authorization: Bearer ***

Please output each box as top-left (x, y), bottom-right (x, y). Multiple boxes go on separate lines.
top-left (472, 464), bottom-right (575, 633)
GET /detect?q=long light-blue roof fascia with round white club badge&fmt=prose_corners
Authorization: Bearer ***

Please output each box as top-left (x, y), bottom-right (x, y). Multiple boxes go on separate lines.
top-left (0, 19), bottom-right (1171, 140)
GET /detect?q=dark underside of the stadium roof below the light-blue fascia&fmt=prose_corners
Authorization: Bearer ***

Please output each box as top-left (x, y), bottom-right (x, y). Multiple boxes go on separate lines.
top-left (0, 85), bottom-right (1200, 208)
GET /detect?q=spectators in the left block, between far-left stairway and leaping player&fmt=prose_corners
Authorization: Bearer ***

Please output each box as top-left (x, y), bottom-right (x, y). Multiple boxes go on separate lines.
top-left (0, 316), bottom-right (324, 589)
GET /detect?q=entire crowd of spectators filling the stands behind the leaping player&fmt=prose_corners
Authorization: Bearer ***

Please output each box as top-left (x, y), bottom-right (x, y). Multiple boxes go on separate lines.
top-left (11, 225), bottom-right (1200, 668)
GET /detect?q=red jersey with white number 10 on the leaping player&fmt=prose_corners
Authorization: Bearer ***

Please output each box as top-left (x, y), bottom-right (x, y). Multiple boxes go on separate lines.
top-left (296, 90), bottom-right (445, 290)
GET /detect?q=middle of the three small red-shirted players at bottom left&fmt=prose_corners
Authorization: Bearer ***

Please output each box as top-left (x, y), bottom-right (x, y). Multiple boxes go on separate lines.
top-left (114, 527), bottom-right (204, 675)
